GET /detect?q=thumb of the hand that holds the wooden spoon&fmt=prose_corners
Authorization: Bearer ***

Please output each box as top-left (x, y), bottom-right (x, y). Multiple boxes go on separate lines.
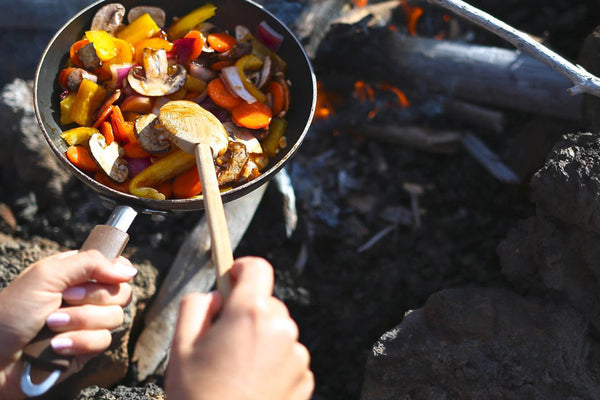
top-left (173, 292), bottom-right (222, 348)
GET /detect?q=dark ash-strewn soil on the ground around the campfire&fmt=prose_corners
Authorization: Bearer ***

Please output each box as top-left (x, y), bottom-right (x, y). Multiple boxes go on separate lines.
top-left (0, 0), bottom-right (600, 399)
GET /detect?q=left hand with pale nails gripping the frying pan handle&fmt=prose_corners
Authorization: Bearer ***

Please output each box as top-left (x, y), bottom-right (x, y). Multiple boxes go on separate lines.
top-left (0, 250), bottom-right (137, 399)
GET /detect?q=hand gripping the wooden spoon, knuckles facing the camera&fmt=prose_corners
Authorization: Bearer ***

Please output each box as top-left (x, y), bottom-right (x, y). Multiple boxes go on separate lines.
top-left (165, 257), bottom-right (314, 400)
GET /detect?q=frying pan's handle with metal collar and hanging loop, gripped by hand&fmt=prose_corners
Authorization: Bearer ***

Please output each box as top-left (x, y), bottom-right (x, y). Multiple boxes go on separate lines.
top-left (21, 206), bottom-right (137, 397)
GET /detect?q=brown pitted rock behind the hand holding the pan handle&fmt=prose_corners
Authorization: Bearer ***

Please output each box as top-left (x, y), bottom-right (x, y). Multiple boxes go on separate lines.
top-left (0, 233), bottom-right (156, 399)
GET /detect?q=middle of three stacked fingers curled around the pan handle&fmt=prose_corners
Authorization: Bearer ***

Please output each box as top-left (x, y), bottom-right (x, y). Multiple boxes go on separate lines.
top-left (46, 305), bottom-right (124, 332)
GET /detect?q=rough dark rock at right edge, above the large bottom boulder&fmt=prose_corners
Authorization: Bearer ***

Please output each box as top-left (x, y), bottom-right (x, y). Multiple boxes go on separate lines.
top-left (531, 133), bottom-right (600, 232)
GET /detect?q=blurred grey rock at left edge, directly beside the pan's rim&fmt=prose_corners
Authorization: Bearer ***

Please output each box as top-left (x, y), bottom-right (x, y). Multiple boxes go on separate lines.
top-left (0, 79), bottom-right (71, 207)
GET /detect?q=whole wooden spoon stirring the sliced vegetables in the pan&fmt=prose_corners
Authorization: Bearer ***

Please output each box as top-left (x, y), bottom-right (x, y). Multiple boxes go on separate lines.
top-left (158, 100), bottom-right (233, 298)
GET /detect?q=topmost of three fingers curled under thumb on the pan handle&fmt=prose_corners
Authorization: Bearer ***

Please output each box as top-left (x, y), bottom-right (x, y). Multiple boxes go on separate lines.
top-left (62, 282), bottom-right (132, 307)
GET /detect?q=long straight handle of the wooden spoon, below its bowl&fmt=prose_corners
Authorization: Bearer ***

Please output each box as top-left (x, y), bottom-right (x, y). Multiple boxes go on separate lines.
top-left (194, 144), bottom-right (233, 299)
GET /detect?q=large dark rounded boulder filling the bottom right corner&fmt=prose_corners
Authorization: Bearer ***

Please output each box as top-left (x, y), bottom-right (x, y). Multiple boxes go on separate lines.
top-left (361, 288), bottom-right (600, 400)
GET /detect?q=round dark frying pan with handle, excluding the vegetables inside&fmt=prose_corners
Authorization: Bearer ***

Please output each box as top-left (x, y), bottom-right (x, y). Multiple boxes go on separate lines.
top-left (21, 0), bottom-right (316, 397)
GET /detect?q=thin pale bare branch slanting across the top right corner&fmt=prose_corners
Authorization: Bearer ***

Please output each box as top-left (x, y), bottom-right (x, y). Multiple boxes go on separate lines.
top-left (428, 0), bottom-right (600, 97)
